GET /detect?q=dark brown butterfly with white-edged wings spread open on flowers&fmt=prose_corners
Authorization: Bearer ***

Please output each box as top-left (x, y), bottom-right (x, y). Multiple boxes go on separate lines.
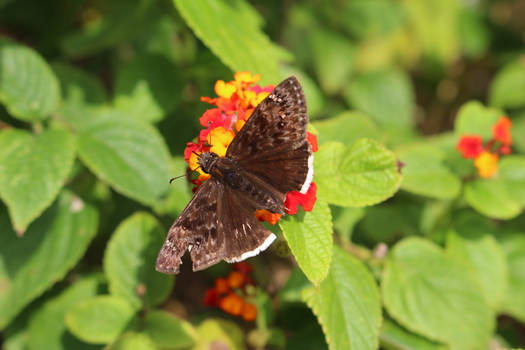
top-left (156, 77), bottom-right (313, 274)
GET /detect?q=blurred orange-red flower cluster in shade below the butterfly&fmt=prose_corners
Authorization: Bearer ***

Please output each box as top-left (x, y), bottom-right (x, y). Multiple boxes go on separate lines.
top-left (202, 262), bottom-right (257, 321)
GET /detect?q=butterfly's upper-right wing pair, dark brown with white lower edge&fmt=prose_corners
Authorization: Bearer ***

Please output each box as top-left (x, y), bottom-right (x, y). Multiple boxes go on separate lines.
top-left (226, 77), bottom-right (313, 196)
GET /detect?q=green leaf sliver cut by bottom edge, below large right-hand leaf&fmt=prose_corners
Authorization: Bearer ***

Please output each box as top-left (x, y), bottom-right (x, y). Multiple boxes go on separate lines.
top-left (379, 319), bottom-right (447, 350)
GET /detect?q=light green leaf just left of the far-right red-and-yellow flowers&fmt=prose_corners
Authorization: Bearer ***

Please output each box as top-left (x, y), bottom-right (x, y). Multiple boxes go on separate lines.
top-left (396, 143), bottom-right (461, 199)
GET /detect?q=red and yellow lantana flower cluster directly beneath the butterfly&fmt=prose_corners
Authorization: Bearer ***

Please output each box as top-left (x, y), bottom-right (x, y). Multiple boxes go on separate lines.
top-left (184, 72), bottom-right (318, 225)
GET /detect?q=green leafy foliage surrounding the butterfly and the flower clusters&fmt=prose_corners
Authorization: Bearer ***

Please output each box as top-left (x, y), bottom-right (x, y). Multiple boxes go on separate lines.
top-left (0, 0), bottom-right (525, 350)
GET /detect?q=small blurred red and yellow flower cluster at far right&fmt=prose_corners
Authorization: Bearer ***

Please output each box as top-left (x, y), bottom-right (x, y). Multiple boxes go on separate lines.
top-left (456, 116), bottom-right (512, 178)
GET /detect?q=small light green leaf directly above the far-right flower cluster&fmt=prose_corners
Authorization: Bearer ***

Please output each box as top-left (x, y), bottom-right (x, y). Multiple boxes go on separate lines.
top-left (454, 101), bottom-right (504, 140)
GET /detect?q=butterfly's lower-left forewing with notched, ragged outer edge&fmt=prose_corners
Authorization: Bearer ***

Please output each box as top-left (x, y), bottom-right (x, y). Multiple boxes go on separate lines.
top-left (156, 178), bottom-right (224, 274)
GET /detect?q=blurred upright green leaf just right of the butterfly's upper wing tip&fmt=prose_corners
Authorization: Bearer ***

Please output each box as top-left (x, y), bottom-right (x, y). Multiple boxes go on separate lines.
top-left (310, 30), bottom-right (355, 94)
